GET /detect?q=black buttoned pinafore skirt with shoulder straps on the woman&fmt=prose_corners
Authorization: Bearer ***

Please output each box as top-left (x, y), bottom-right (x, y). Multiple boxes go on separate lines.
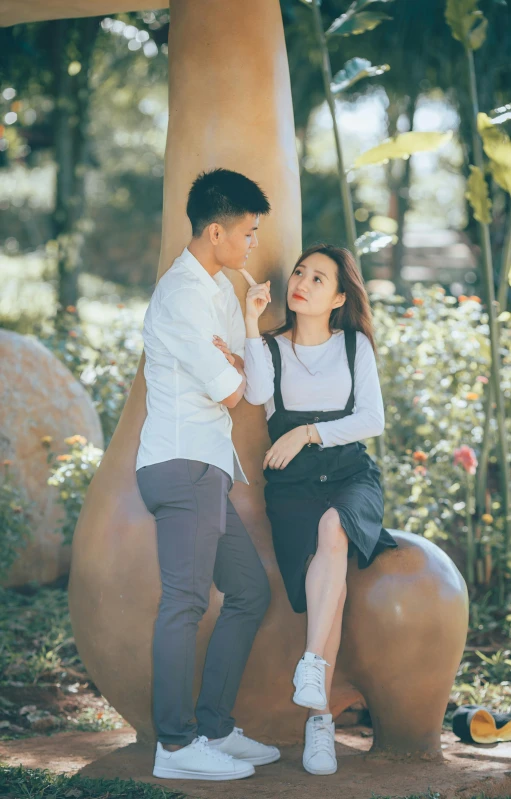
top-left (264, 330), bottom-right (397, 613)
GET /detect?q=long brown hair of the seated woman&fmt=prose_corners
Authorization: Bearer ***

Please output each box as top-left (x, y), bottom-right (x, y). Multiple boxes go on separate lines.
top-left (268, 244), bottom-right (376, 352)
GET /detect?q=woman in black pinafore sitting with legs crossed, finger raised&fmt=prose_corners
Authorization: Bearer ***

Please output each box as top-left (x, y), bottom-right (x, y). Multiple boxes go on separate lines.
top-left (217, 245), bottom-right (397, 774)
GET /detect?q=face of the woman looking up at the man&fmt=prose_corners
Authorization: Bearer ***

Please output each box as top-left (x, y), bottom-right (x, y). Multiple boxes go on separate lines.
top-left (287, 252), bottom-right (346, 317)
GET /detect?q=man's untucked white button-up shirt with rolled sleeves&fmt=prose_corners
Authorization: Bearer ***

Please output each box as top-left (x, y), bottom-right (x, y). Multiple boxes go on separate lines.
top-left (136, 248), bottom-right (248, 484)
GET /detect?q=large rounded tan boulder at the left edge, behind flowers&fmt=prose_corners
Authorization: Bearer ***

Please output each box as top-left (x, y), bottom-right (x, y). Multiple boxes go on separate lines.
top-left (0, 330), bottom-right (103, 586)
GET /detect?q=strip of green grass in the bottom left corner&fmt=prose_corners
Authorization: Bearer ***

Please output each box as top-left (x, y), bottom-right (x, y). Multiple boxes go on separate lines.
top-left (0, 765), bottom-right (186, 799)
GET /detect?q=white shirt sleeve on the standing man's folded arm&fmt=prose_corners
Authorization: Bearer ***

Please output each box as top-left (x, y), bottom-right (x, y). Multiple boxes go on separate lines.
top-left (152, 287), bottom-right (243, 402)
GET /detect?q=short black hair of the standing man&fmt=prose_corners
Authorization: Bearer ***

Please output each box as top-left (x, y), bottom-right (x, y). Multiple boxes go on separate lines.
top-left (186, 169), bottom-right (271, 237)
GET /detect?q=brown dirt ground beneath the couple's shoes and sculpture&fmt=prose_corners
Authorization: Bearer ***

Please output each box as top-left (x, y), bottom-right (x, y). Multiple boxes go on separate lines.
top-left (0, 726), bottom-right (511, 799)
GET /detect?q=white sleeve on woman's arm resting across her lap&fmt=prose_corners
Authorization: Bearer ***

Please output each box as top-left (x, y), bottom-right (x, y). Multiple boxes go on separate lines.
top-left (316, 332), bottom-right (385, 447)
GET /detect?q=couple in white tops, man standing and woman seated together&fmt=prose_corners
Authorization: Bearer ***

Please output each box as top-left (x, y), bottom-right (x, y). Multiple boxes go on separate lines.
top-left (136, 169), bottom-right (396, 780)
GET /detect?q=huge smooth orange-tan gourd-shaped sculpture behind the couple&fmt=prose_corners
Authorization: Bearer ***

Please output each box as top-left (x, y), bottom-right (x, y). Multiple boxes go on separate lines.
top-left (70, 0), bottom-right (467, 755)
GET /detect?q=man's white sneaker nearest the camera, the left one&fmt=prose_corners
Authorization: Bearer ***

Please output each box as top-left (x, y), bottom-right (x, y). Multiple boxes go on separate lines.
top-left (153, 735), bottom-right (255, 780)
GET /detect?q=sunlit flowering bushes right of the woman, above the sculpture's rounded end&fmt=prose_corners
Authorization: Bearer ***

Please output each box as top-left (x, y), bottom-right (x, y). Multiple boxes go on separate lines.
top-left (374, 286), bottom-right (511, 564)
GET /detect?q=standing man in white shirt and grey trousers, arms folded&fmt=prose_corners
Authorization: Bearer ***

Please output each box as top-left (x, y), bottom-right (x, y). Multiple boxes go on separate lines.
top-left (136, 169), bottom-right (280, 780)
